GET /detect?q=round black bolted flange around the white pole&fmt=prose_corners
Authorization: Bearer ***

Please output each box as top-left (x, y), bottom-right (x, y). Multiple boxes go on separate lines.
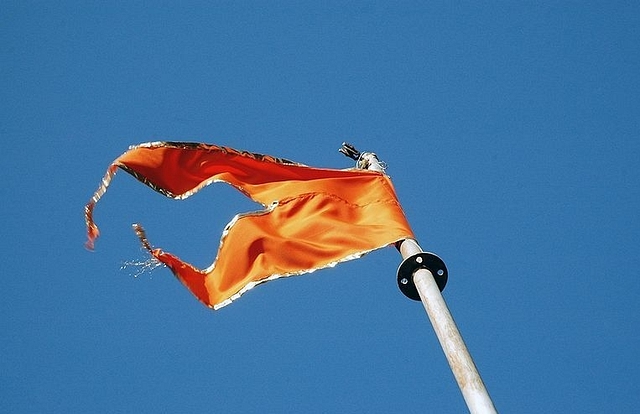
top-left (398, 252), bottom-right (449, 300)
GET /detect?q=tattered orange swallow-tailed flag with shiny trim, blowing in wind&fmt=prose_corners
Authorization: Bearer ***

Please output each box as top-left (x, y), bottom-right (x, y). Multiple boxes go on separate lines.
top-left (85, 142), bottom-right (413, 309)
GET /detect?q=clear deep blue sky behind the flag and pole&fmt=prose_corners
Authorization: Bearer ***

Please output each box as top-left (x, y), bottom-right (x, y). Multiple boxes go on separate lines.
top-left (0, 1), bottom-right (640, 413)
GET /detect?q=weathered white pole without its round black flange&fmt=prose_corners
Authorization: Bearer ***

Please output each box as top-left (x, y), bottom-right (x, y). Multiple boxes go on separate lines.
top-left (356, 144), bottom-right (496, 414)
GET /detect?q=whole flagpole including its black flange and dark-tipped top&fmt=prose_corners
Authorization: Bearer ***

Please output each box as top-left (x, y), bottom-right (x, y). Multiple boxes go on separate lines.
top-left (340, 143), bottom-right (496, 414)
